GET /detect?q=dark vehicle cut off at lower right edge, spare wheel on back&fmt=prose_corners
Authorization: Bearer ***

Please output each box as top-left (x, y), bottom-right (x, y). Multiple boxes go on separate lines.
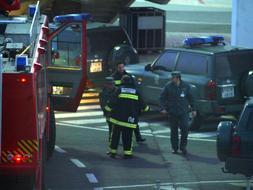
top-left (217, 98), bottom-right (253, 177)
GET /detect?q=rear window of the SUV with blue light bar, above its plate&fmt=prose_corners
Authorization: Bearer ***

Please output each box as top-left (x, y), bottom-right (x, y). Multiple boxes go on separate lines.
top-left (215, 52), bottom-right (253, 78)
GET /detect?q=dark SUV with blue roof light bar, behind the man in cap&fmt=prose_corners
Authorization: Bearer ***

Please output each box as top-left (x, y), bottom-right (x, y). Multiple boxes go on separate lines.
top-left (126, 36), bottom-right (253, 129)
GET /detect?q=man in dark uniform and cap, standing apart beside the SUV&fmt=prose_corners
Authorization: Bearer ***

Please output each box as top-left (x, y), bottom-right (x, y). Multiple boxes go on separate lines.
top-left (160, 71), bottom-right (196, 154)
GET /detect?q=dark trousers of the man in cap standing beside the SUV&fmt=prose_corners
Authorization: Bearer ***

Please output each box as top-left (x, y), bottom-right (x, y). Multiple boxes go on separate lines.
top-left (169, 113), bottom-right (189, 150)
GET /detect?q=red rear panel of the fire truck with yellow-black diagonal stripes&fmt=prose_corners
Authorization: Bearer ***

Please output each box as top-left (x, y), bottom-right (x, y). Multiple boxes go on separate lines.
top-left (0, 73), bottom-right (40, 174)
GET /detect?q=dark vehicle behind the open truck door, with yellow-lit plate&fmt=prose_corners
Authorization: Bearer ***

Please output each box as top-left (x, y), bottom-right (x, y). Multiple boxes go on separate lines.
top-left (50, 23), bottom-right (138, 87)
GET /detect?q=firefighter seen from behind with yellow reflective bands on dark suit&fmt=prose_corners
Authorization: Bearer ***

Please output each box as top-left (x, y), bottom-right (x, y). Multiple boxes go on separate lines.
top-left (106, 75), bottom-right (149, 158)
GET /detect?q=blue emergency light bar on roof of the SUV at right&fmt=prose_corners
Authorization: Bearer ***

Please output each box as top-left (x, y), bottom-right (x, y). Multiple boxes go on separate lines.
top-left (183, 36), bottom-right (225, 47)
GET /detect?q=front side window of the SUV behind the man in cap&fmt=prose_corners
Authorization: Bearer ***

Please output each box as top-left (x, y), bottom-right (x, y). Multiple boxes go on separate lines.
top-left (154, 52), bottom-right (177, 71)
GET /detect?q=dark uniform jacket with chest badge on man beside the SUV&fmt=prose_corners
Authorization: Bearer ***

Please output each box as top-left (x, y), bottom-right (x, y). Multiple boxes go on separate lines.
top-left (160, 81), bottom-right (193, 115)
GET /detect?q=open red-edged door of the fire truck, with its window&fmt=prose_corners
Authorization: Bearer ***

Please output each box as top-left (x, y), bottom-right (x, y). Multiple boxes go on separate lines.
top-left (47, 23), bottom-right (87, 111)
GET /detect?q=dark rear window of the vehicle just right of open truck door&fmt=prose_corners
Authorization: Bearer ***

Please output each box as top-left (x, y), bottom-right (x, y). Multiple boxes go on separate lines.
top-left (88, 28), bottom-right (129, 52)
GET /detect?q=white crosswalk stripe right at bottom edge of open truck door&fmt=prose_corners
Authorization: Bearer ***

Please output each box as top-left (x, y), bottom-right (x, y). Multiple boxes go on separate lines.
top-left (55, 111), bottom-right (103, 119)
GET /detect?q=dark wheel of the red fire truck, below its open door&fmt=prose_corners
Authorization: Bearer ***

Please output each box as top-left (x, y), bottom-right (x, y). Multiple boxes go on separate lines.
top-left (47, 102), bottom-right (56, 160)
